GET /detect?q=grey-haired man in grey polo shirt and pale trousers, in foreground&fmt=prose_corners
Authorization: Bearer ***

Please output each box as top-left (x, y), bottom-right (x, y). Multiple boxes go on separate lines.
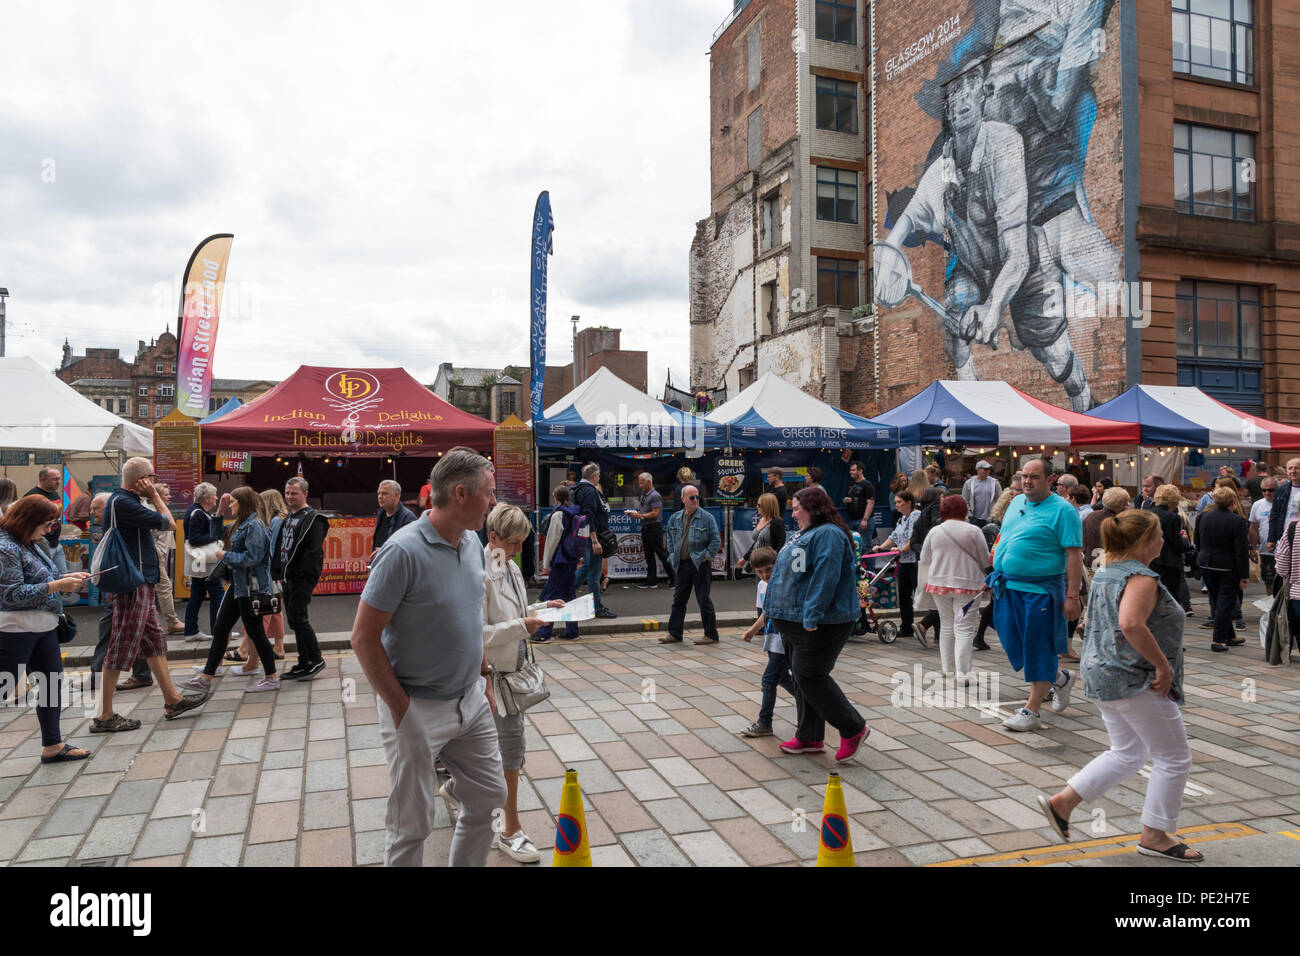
top-left (352, 447), bottom-right (506, 866)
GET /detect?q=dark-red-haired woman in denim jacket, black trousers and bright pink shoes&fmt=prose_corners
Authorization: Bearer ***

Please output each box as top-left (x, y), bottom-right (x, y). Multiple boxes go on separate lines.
top-left (764, 486), bottom-right (868, 762)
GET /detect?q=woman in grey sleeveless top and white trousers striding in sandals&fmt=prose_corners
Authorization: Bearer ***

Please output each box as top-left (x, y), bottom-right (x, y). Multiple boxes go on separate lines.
top-left (1039, 510), bottom-right (1205, 862)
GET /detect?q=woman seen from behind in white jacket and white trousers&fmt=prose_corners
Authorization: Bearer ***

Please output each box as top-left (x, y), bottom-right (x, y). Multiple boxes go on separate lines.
top-left (919, 494), bottom-right (989, 684)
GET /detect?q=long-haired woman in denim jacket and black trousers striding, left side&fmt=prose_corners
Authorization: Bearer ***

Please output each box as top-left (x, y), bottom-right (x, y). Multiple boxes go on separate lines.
top-left (185, 485), bottom-right (280, 691)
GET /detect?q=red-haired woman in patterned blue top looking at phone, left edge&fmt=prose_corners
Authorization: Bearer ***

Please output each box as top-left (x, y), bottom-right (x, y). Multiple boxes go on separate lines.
top-left (0, 494), bottom-right (90, 763)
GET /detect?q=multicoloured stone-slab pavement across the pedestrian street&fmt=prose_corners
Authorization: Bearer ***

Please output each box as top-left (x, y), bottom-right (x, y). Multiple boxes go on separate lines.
top-left (0, 613), bottom-right (1300, 866)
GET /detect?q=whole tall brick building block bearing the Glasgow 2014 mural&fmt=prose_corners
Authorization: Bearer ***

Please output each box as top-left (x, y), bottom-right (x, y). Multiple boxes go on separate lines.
top-left (692, 0), bottom-right (1300, 437)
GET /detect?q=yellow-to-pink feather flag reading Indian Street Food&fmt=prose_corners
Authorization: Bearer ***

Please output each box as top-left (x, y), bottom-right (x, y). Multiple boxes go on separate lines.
top-left (176, 233), bottom-right (235, 419)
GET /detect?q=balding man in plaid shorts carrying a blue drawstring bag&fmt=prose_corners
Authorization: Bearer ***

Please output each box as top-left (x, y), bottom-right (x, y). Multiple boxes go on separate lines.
top-left (90, 458), bottom-right (208, 734)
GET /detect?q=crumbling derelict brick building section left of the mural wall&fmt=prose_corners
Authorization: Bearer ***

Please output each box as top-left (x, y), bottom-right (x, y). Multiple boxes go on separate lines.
top-left (690, 0), bottom-right (871, 403)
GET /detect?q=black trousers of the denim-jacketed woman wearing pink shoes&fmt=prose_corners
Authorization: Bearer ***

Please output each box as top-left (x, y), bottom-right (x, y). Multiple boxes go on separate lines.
top-left (775, 620), bottom-right (867, 744)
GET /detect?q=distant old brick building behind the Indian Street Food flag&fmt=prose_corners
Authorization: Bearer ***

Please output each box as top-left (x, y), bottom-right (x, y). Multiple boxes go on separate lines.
top-left (55, 328), bottom-right (277, 428)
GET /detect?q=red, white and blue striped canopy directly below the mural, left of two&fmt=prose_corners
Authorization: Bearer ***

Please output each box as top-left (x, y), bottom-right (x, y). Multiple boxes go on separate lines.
top-left (875, 381), bottom-right (1140, 447)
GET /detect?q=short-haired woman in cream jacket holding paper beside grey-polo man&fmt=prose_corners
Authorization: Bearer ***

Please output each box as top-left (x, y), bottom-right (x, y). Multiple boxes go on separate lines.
top-left (484, 505), bottom-right (564, 864)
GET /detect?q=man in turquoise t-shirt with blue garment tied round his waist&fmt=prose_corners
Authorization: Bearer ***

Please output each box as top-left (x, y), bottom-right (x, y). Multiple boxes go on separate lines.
top-left (989, 459), bottom-right (1083, 731)
